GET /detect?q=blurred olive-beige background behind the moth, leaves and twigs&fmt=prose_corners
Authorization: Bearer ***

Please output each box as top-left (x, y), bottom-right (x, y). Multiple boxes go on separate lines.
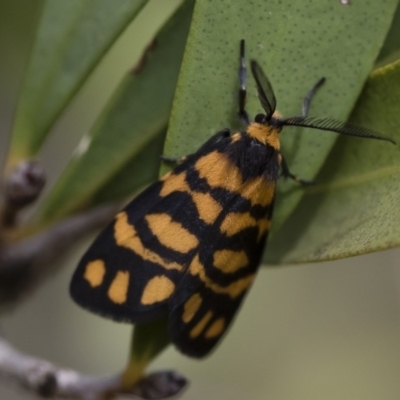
top-left (0, 0), bottom-right (400, 400)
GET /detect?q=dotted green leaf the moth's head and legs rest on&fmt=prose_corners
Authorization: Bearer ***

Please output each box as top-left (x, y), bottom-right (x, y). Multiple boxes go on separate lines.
top-left (165, 0), bottom-right (398, 234)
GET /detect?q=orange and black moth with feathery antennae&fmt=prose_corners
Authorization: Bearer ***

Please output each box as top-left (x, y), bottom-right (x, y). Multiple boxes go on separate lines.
top-left (71, 41), bottom-right (391, 357)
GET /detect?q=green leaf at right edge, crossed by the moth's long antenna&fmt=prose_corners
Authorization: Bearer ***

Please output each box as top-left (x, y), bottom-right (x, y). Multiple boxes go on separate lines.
top-left (266, 60), bottom-right (400, 263)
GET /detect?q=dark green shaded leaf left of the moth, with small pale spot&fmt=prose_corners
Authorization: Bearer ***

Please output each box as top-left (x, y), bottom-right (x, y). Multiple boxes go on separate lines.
top-left (39, 0), bottom-right (194, 223)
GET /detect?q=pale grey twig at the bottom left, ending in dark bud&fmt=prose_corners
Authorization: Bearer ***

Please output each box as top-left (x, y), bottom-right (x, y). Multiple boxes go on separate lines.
top-left (0, 337), bottom-right (187, 400)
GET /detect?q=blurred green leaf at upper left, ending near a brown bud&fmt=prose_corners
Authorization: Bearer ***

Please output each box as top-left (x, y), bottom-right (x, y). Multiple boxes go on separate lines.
top-left (8, 0), bottom-right (147, 167)
